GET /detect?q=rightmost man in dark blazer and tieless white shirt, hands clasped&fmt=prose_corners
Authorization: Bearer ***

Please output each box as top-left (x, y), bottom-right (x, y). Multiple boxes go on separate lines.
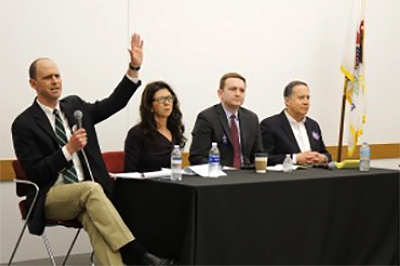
top-left (261, 81), bottom-right (332, 165)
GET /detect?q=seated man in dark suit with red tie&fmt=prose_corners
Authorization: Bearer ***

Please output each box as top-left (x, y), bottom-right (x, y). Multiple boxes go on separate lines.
top-left (189, 73), bottom-right (263, 168)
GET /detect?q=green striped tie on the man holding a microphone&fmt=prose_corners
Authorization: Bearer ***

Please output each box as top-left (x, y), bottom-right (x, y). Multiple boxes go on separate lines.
top-left (53, 109), bottom-right (79, 184)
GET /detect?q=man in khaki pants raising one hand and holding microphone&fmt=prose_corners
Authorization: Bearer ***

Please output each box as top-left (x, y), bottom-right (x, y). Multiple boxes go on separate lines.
top-left (12, 34), bottom-right (173, 266)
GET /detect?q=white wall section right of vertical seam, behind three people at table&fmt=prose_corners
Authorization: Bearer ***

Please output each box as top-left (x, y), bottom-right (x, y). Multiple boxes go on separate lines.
top-left (130, 0), bottom-right (400, 150)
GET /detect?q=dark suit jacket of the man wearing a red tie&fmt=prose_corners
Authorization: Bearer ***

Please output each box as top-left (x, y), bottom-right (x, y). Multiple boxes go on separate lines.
top-left (189, 104), bottom-right (263, 166)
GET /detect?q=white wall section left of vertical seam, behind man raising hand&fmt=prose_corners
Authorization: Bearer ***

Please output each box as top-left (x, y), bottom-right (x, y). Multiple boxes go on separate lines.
top-left (0, 0), bottom-right (129, 158)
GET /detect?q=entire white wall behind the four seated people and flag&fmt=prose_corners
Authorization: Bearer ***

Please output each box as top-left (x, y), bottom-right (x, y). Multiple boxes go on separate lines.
top-left (0, 0), bottom-right (400, 263)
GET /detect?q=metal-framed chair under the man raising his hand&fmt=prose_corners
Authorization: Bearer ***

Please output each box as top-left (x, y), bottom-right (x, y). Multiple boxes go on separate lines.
top-left (8, 160), bottom-right (94, 266)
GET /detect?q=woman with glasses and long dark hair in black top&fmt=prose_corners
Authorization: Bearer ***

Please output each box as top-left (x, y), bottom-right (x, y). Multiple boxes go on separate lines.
top-left (124, 81), bottom-right (186, 173)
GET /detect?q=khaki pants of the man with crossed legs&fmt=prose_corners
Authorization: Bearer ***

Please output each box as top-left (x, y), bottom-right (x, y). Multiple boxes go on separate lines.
top-left (45, 182), bottom-right (134, 266)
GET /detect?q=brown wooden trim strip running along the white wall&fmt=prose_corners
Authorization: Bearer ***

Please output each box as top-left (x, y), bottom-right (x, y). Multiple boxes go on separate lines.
top-left (0, 143), bottom-right (400, 181)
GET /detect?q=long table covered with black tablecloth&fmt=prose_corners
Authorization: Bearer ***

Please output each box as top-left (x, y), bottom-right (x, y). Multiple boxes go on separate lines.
top-left (113, 169), bottom-right (400, 266)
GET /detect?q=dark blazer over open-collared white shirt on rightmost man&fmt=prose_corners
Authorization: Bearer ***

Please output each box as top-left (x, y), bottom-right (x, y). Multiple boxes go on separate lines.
top-left (261, 111), bottom-right (332, 165)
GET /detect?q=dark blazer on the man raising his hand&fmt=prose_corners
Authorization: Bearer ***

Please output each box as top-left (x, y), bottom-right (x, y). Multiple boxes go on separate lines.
top-left (11, 77), bottom-right (140, 235)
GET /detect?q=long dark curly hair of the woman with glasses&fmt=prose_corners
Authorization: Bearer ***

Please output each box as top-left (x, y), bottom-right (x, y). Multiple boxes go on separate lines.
top-left (139, 81), bottom-right (186, 148)
